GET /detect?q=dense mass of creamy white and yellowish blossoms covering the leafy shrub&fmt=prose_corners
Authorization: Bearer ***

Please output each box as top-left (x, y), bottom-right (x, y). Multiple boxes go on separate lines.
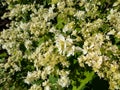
top-left (0, 0), bottom-right (120, 90)
